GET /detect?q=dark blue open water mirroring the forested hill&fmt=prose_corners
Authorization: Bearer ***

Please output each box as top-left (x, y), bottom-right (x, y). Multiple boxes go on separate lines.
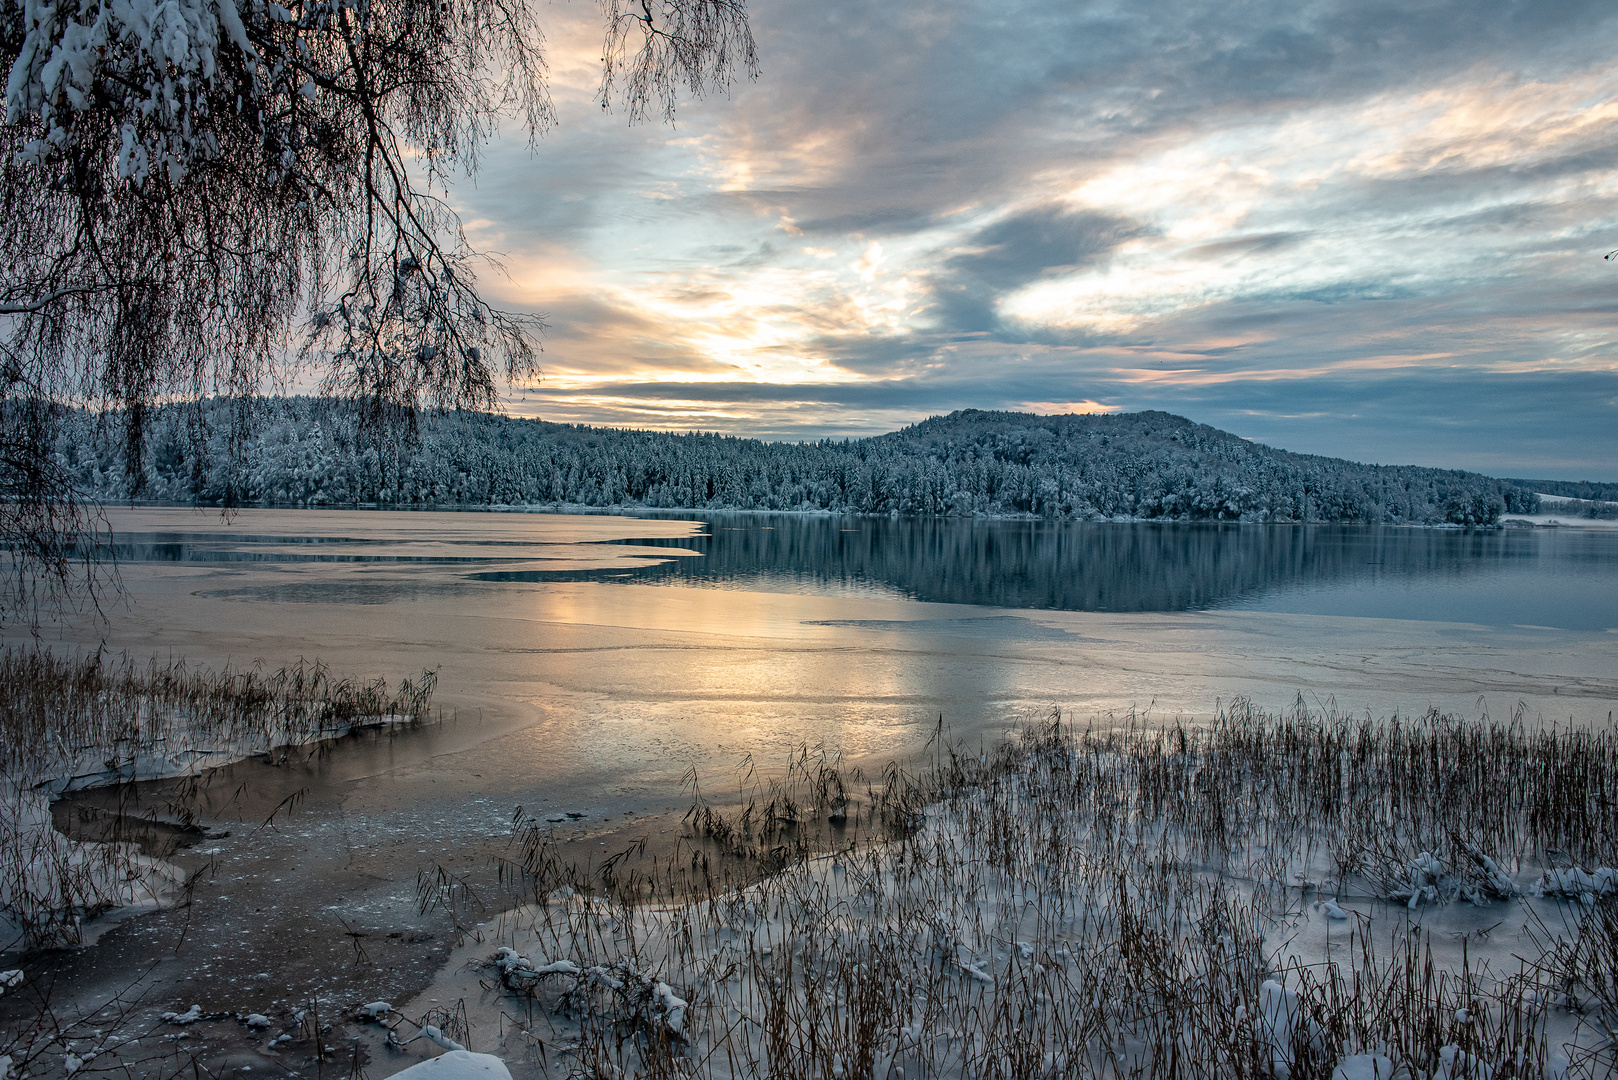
top-left (472, 515), bottom-right (1618, 630)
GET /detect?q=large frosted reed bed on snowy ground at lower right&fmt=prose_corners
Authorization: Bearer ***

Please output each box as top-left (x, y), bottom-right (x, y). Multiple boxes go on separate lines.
top-left (417, 706), bottom-right (1618, 1080)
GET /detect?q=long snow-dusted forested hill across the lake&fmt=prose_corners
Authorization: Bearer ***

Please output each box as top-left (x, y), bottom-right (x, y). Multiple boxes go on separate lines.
top-left (58, 398), bottom-right (1539, 525)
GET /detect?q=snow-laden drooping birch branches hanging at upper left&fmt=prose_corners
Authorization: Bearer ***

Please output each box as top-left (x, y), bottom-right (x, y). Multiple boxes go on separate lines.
top-left (0, 0), bottom-right (756, 621)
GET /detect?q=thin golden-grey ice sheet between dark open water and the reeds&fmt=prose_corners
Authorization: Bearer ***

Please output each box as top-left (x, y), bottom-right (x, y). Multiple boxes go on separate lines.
top-left (0, 512), bottom-right (1618, 1077)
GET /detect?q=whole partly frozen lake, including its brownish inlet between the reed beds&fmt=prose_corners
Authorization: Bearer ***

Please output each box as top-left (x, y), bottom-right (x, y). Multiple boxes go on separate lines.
top-left (11, 508), bottom-right (1618, 1002)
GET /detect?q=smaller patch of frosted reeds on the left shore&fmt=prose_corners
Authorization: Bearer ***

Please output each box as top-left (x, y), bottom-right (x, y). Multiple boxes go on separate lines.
top-left (0, 651), bottom-right (435, 950)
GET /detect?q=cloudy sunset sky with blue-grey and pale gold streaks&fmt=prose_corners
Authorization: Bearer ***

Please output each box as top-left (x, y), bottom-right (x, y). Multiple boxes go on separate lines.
top-left (450, 0), bottom-right (1618, 481)
